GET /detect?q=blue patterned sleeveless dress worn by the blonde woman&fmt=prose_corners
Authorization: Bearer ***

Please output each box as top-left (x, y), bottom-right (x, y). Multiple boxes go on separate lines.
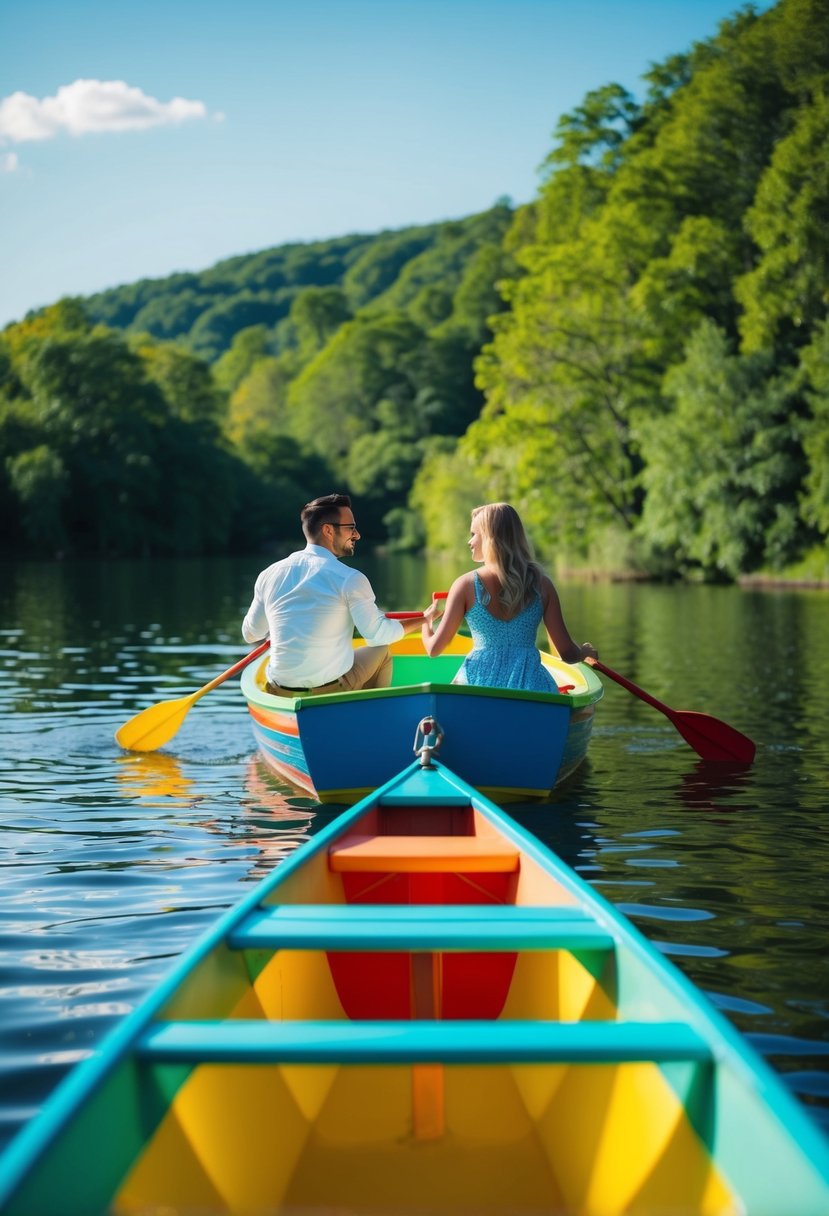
top-left (453, 572), bottom-right (558, 692)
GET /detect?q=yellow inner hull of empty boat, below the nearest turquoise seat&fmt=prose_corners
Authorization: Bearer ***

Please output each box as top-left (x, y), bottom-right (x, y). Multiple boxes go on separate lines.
top-left (114, 1064), bottom-right (741, 1216)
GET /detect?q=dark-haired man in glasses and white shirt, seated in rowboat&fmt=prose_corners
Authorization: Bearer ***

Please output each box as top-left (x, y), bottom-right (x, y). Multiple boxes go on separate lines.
top-left (242, 494), bottom-right (435, 697)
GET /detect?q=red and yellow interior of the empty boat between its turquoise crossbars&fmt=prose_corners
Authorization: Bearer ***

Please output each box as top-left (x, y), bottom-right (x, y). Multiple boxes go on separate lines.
top-left (112, 807), bottom-right (743, 1216)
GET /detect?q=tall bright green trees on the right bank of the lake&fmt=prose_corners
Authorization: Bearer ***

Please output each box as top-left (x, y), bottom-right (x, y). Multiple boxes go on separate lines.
top-left (415, 0), bottom-right (829, 578)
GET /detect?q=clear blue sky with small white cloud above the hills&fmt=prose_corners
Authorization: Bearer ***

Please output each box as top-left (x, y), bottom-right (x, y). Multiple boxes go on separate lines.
top-left (0, 0), bottom-right (772, 327)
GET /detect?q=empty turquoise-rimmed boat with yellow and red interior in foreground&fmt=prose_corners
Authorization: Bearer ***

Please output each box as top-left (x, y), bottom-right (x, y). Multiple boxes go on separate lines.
top-left (0, 724), bottom-right (829, 1216)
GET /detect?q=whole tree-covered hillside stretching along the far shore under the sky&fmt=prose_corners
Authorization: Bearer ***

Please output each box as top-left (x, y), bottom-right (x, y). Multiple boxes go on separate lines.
top-left (0, 0), bottom-right (829, 579)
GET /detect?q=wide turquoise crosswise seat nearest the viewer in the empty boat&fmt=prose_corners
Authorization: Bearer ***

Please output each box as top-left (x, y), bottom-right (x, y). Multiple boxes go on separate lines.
top-left (137, 1019), bottom-right (712, 1065)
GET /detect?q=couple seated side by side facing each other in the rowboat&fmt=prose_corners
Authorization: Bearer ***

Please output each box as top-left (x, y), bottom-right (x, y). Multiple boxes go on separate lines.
top-left (242, 494), bottom-right (597, 697)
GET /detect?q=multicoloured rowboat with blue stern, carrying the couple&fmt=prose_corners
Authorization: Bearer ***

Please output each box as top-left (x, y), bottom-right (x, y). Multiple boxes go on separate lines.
top-left (242, 636), bottom-right (603, 804)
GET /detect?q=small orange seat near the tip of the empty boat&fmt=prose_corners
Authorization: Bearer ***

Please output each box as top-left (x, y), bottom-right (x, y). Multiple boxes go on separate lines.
top-left (328, 835), bottom-right (520, 874)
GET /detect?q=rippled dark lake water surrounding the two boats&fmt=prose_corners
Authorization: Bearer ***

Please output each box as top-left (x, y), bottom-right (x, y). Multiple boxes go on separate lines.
top-left (0, 559), bottom-right (829, 1144)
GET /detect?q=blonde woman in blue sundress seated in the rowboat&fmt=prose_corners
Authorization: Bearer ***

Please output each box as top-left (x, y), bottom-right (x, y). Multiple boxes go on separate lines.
top-left (422, 502), bottom-right (598, 692)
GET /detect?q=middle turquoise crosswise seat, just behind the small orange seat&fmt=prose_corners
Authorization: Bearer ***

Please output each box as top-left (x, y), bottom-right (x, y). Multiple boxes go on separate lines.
top-left (229, 903), bottom-right (614, 952)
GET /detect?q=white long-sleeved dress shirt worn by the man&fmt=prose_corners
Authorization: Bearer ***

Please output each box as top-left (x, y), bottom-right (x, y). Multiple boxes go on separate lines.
top-left (242, 544), bottom-right (405, 688)
